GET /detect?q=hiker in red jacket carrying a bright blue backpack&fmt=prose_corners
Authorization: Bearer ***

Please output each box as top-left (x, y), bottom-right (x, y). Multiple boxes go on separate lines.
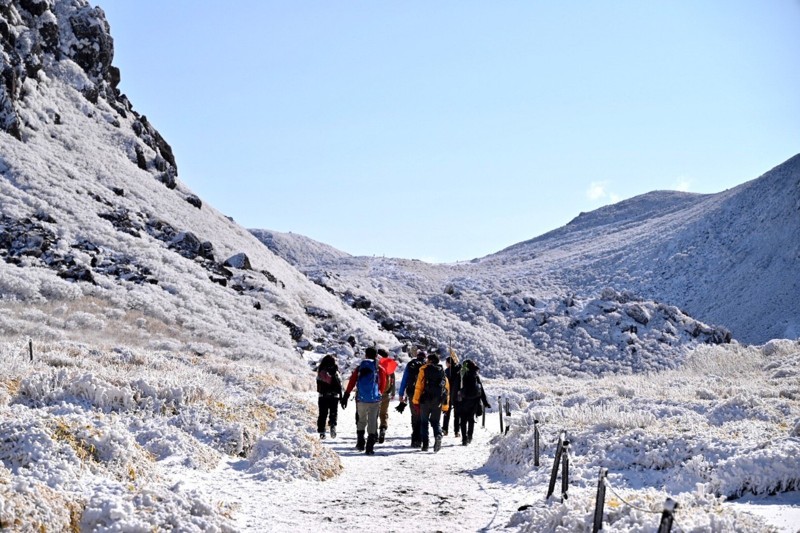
top-left (341, 346), bottom-right (386, 455)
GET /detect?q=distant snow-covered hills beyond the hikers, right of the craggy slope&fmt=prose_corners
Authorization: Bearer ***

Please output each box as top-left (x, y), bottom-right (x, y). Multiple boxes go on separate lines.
top-left (254, 156), bottom-right (800, 376)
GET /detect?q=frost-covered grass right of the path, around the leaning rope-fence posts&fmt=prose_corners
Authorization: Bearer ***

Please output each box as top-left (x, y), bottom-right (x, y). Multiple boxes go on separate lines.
top-left (486, 341), bottom-right (800, 531)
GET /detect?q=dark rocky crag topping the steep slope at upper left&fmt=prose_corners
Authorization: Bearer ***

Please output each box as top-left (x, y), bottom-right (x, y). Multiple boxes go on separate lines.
top-left (0, 0), bottom-right (178, 187)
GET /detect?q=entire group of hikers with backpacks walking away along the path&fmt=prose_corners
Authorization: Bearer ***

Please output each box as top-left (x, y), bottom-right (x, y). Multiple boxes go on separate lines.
top-left (317, 346), bottom-right (491, 455)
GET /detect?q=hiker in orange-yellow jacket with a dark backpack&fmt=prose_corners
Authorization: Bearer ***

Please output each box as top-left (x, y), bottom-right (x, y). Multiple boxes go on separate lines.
top-left (411, 353), bottom-right (450, 452)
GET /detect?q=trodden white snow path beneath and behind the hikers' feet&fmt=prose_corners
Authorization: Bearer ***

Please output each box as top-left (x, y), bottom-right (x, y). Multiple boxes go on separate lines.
top-left (175, 392), bottom-right (534, 532)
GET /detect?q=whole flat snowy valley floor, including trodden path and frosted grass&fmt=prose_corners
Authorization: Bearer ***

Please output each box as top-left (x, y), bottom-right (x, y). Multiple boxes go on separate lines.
top-left (0, 341), bottom-right (800, 532)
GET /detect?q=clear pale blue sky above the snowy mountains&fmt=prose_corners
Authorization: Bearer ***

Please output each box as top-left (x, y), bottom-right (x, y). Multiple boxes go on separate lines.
top-left (98, 0), bottom-right (800, 262)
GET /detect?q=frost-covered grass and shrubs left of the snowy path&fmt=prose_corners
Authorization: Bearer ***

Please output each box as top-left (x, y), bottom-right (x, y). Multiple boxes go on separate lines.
top-left (0, 341), bottom-right (340, 531)
